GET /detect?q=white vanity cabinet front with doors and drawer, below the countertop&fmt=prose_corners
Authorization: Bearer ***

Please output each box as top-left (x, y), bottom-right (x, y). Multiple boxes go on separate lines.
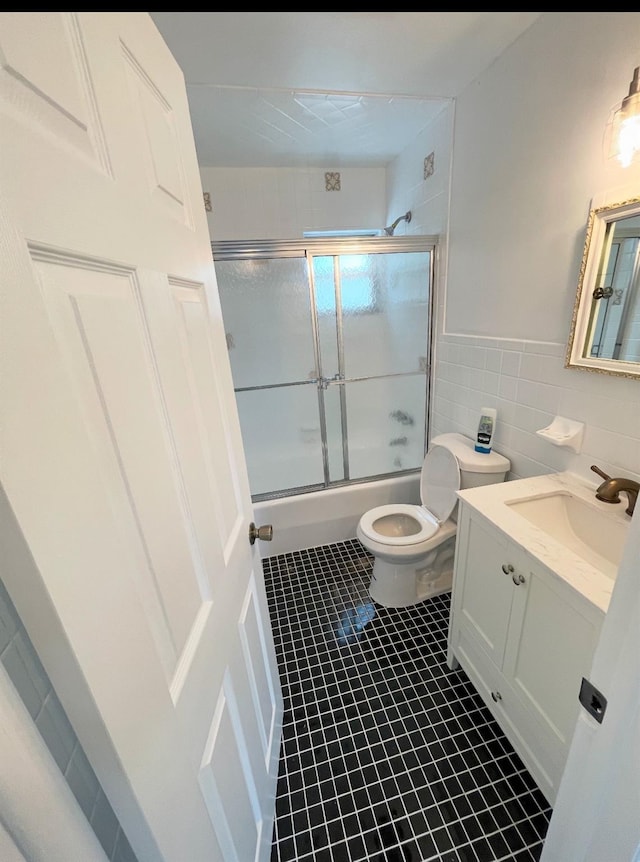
top-left (448, 500), bottom-right (604, 805)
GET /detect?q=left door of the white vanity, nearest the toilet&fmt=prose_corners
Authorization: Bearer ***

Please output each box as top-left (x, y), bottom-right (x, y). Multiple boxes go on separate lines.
top-left (450, 503), bottom-right (518, 668)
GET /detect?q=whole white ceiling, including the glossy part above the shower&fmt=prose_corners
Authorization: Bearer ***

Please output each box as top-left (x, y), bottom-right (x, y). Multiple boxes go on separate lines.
top-left (149, 12), bottom-right (541, 168)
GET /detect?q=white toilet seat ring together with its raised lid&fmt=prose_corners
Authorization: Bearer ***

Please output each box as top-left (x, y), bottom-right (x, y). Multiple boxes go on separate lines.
top-left (359, 445), bottom-right (460, 548)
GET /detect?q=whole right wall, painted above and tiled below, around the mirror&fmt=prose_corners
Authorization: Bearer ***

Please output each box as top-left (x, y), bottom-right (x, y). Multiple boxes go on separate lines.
top-left (431, 12), bottom-right (640, 482)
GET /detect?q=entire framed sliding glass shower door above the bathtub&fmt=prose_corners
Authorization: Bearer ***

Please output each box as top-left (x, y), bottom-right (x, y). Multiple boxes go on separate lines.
top-left (212, 237), bottom-right (434, 500)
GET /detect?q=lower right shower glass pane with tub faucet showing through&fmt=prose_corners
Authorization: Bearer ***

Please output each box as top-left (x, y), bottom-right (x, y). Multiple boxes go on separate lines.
top-left (345, 374), bottom-right (427, 479)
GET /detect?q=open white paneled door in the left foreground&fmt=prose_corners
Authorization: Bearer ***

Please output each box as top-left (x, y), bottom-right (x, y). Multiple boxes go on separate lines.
top-left (0, 12), bottom-right (282, 862)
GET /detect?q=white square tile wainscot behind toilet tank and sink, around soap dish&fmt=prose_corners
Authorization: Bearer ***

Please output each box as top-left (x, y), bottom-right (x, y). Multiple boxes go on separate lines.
top-left (431, 333), bottom-right (640, 483)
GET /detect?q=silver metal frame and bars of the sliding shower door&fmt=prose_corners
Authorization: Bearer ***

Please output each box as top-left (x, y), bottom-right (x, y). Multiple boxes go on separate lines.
top-left (211, 236), bottom-right (438, 503)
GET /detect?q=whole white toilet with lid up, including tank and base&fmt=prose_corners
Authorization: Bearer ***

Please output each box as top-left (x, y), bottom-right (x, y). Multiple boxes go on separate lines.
top-left (356, 433), bottom-right (511, 608)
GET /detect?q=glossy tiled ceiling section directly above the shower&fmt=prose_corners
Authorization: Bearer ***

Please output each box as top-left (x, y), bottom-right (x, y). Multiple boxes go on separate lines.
top-left (180, 84), bottom-right (449, 168)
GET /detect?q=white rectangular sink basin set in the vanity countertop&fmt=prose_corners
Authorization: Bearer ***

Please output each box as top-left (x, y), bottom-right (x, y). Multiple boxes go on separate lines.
top-left (506, 491), bottom-right (628, 578)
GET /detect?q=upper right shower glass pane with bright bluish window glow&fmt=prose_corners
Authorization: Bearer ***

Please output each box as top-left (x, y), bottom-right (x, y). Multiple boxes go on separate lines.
top-left (340, 252), bottom-right (431, 379)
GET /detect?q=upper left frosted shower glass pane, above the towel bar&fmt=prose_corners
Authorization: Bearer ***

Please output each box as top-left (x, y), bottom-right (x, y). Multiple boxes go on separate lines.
top-left (216, 257), bottom-right (316, 389)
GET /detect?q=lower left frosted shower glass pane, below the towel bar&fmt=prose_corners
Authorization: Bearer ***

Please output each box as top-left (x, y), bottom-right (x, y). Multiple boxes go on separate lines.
top-left (236, 385), bottom-right (324, 497)
